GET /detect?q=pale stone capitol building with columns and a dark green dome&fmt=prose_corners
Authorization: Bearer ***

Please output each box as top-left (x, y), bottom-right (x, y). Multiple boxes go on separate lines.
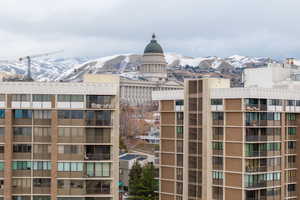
top-left (120, 34), bottom-right (183, 105)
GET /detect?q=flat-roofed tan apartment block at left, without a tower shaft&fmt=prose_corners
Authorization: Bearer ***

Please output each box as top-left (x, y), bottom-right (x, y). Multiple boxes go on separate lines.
top-left (0, 77), bottom-right (119, 200)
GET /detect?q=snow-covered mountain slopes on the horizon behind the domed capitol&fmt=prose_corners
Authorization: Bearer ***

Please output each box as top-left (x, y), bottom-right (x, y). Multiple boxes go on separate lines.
top-left (0, 53), bottom-right (271, 81)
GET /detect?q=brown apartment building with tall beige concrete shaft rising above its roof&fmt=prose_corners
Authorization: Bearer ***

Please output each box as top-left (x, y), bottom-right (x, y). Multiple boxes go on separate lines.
top-left (153, 78), bottom-right (300, 200)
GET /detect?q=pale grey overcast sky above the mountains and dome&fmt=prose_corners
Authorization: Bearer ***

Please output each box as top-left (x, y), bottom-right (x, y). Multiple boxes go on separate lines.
top-left (0, 0), bottom-right (300, 59)
